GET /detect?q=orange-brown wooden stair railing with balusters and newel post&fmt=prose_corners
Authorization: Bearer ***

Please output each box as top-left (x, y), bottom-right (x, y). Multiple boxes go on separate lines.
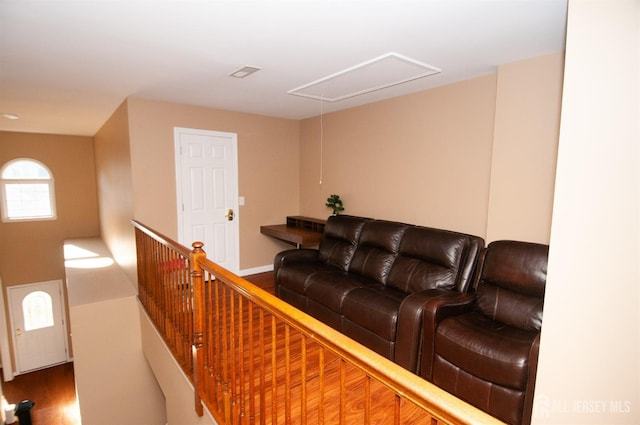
top-left (133, 221), bottom-right (502, 425)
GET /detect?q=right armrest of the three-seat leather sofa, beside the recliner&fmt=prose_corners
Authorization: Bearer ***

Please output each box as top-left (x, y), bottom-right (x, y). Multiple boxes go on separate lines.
top-left (394, 289), bottom-right (472, 373)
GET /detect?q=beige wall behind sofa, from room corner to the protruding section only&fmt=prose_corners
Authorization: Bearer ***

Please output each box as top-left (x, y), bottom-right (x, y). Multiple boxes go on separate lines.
top-left (300, 75), bottom-right (496, 235)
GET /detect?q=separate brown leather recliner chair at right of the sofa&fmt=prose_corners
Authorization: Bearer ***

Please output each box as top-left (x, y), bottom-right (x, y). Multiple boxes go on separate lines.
top-left (420, 241), bottom-right (549, 424)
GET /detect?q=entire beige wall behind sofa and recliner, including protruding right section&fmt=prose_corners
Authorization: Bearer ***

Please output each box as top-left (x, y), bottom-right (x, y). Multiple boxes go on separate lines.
top-left (300, 54), bottom-right (563, 243)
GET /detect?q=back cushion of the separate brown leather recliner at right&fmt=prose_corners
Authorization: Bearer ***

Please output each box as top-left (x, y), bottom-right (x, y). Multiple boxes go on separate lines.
top-left (474, 241), bottom-right (549, 331)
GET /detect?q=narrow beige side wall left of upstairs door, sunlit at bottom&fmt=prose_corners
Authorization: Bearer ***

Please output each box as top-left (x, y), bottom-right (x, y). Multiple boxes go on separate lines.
top-left (94, 101), bottom-right (138, 286)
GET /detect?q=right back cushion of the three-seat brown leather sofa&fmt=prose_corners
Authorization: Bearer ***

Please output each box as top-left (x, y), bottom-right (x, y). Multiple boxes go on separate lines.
top-left (387, 226), bottom-right (484, 292)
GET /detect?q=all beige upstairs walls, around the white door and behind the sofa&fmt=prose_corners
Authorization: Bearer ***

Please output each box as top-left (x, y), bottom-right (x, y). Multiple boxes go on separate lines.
top-left (95, 54), bottom-right (563, 274)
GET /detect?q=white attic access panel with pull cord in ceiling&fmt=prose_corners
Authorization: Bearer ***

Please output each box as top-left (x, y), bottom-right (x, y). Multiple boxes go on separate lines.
top-left (288, 53), bottom-right (441, 102)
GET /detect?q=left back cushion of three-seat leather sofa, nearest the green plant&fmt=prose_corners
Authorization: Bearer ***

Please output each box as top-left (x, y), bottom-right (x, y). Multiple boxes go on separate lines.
top-left (318, 215), bottom-right (370, 271)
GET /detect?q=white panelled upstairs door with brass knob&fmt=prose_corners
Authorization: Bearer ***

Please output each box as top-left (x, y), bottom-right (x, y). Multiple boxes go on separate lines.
top-left (175, 128), bottom-right (239, 273)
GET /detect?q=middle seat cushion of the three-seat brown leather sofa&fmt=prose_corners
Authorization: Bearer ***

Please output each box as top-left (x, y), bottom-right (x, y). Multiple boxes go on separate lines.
top-left (306, 270), bottom-right (372, 313)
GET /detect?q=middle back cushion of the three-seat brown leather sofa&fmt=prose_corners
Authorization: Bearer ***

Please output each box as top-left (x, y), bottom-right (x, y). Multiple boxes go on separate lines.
top-left (349, 220), bottom-right (408, 284)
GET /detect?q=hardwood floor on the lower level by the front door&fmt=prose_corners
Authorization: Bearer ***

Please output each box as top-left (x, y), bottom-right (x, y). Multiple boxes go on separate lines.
top-left (2, 363), bottom-right (81, 425)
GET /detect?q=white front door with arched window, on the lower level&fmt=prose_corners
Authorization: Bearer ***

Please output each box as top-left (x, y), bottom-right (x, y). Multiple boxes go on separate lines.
top-left (7, 280), bottom-right (68, 374)
